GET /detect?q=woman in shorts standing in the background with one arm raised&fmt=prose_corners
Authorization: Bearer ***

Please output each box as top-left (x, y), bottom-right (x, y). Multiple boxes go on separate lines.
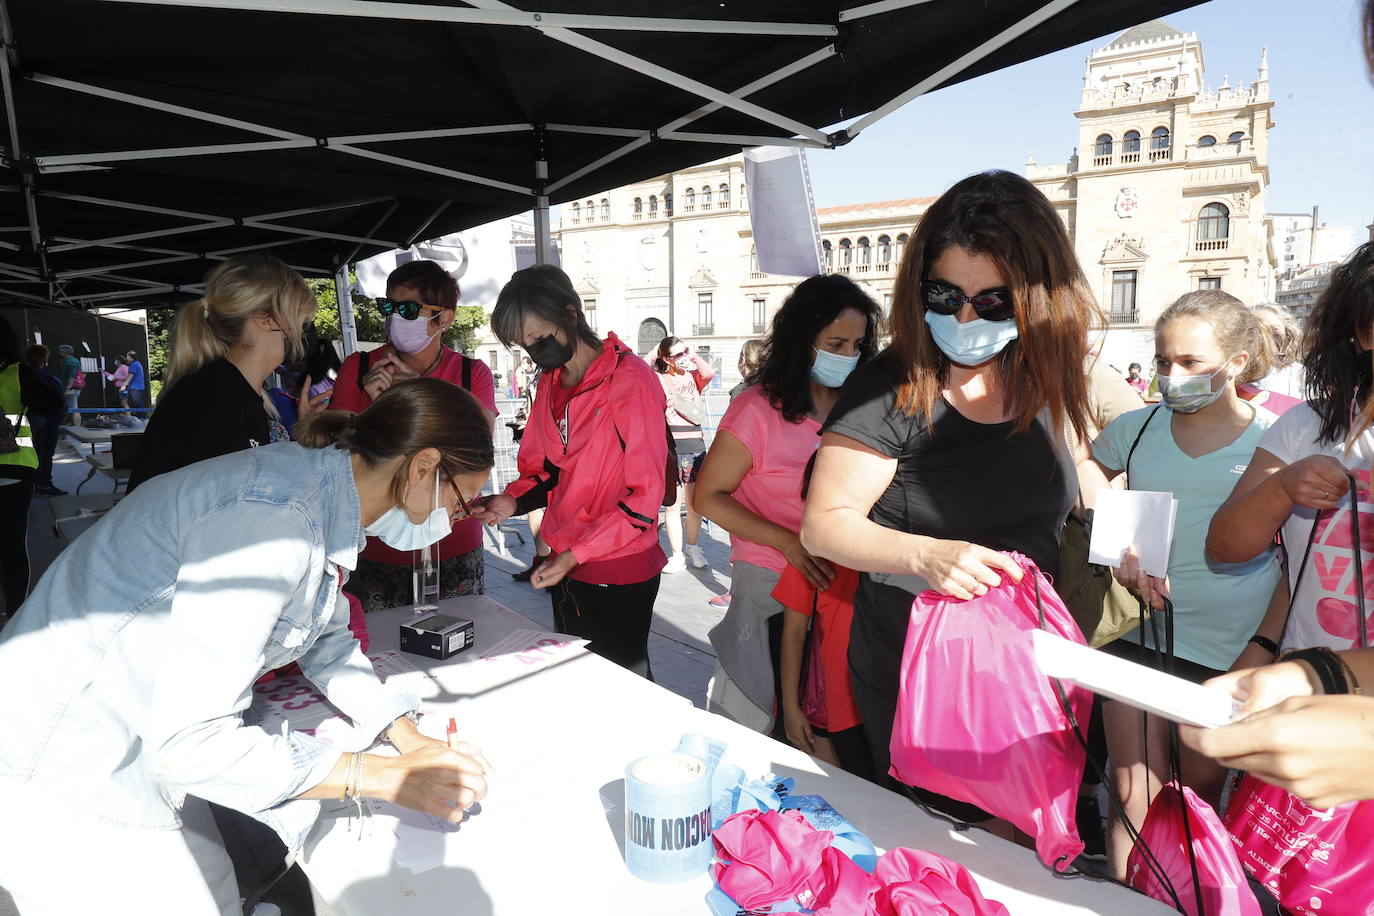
top-left (654, 335), bottom-right (716, 573)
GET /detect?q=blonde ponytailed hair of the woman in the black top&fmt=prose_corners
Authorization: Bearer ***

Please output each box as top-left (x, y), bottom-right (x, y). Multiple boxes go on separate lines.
top-left (162, 254), bottom-right (315, 395)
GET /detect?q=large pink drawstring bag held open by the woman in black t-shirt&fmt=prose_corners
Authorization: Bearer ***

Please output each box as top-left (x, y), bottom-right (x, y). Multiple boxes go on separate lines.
top-left (889, 553), bottom-right (1092, 871)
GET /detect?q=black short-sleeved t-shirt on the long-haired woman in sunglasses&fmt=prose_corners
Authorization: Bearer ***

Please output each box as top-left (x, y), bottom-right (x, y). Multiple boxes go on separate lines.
top-left (824, 353), bottom-right (1077, 696)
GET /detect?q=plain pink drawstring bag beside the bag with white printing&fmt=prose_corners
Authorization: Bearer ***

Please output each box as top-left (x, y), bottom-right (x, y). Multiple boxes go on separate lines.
top-left (1125, 783), bottom-right (1263, 916)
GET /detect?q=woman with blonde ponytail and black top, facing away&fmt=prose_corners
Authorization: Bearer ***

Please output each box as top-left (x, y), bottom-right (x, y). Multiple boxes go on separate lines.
top-left (129, 254), bottom-right (324, 493)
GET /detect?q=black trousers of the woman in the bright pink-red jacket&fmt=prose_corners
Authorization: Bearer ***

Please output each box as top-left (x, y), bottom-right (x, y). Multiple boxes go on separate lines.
top-left (548, 575), bottom-right (660, 680)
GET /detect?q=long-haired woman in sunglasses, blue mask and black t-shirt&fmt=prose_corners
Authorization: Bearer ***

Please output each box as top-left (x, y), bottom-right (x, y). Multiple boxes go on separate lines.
top-left (801, 172), bottom-right (1102, 821)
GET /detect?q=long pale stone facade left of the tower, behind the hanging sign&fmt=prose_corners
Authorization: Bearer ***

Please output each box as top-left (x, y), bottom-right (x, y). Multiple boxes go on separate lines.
top-left (481, 157), bottom-right (934, 387)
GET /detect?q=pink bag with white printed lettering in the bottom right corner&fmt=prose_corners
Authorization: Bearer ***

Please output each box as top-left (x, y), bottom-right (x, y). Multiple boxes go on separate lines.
top-left (1226, 773), bottom-right (1374, 916)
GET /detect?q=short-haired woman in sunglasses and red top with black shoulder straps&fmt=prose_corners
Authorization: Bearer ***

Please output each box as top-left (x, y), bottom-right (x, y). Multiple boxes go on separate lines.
top-left (330, 261), bottom-right (496, 611)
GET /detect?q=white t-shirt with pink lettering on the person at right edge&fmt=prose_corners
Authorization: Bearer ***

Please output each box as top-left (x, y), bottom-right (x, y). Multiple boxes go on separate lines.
top-left (1260, 402), bottom-right (1374, 650)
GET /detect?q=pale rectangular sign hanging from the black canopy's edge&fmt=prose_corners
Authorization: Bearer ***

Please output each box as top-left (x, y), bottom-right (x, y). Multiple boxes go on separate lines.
top-left (745, 147), bottom-right (820, 276)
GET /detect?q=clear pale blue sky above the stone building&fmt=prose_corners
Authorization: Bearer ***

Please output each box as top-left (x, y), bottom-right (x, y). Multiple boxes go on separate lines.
top-left (808, 0), bottom-right (1374, 238)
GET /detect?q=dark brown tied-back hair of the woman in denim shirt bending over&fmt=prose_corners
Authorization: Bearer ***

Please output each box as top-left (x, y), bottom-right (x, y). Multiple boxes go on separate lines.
top-left (294, 379), bottom-right (496, 503)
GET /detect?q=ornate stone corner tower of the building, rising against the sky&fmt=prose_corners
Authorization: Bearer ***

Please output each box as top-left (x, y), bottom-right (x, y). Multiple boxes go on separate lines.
top-left (1026, 19), bottom-right (1275, 339)
